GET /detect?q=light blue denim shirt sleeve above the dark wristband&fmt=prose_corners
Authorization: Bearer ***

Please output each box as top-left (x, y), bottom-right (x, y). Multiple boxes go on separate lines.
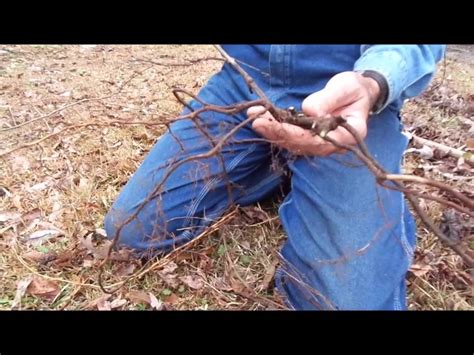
top-left (354, 45), bottom-right (446, 112)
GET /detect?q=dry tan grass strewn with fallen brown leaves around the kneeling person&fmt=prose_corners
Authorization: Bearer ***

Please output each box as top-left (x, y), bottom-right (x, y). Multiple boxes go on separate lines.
top-left (0, 46), bottom-right (474, 309)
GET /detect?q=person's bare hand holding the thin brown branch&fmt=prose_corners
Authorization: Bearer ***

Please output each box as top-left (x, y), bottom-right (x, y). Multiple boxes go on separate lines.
top-left (252, 72), bottom-right (380, 156)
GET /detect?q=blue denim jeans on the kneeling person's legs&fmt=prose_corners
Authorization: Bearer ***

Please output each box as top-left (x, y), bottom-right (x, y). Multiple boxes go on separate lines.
top-left (105, 46), bottom-right (415, 310)
